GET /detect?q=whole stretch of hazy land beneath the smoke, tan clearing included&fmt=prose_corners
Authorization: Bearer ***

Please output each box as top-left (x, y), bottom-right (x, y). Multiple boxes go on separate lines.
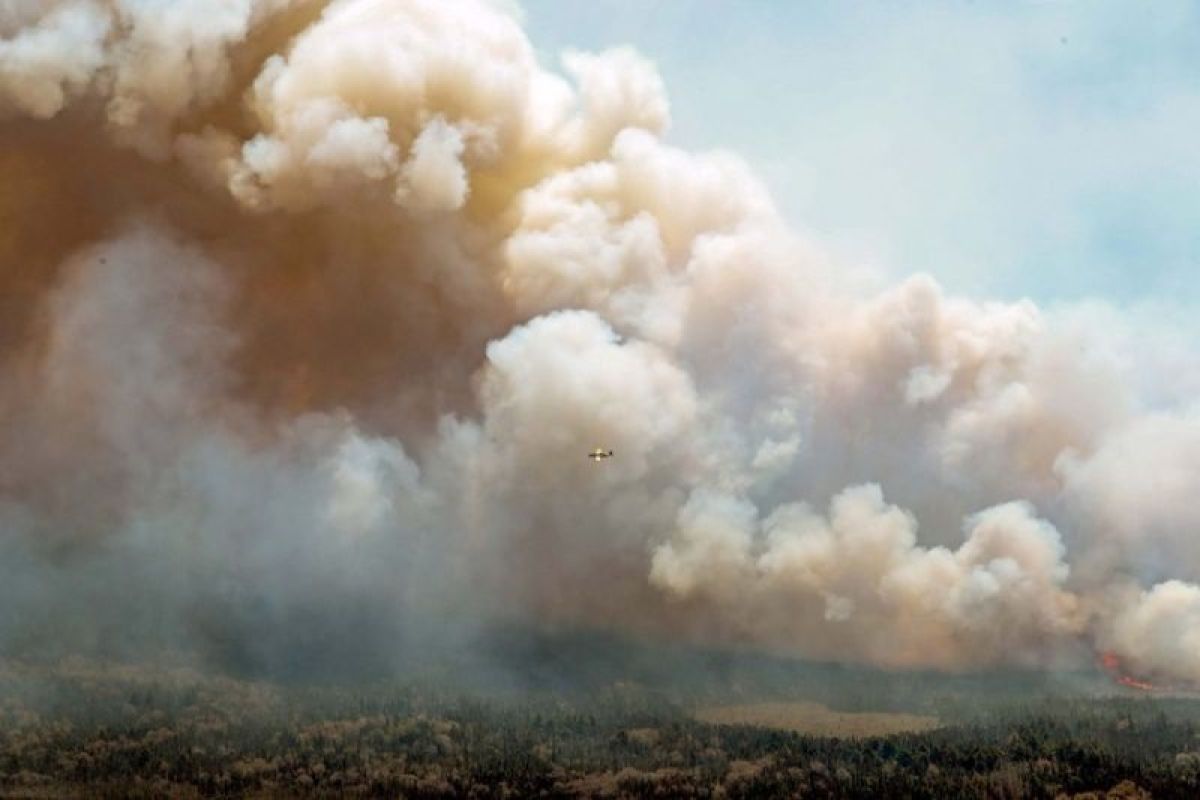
top-left (0, 637), bottom-right (1200, 798)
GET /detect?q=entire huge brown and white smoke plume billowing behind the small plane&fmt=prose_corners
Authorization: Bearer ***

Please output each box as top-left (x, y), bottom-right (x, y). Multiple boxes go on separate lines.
top-left (0, 0), bottom-right (1200, 681)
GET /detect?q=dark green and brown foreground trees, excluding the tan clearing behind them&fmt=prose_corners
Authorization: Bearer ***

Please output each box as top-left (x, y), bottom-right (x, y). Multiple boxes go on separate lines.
top-left (0, 674), bottom-right (1200, 798)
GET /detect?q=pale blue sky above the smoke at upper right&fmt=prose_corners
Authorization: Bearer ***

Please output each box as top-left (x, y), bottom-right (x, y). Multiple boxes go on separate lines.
top-left (520, 0), bottom-right (1200, 305)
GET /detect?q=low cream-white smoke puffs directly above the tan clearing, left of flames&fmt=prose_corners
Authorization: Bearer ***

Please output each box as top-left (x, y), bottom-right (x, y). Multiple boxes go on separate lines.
top-left (650, 486), bottom-right (1085, 668)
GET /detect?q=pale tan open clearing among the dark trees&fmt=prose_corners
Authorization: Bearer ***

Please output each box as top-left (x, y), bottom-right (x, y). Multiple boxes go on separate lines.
top-left (695, 703), bottom-right (941, 739)
